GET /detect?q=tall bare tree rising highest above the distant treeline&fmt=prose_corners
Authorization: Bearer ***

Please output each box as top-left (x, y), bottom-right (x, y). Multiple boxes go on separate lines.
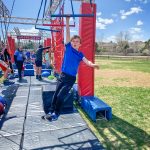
top-left (116, 32), bottom-right (130, 55)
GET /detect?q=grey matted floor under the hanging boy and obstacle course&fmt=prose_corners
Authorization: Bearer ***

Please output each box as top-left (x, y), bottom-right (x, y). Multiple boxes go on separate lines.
top-left (0, 77), bottom-right (103, 150)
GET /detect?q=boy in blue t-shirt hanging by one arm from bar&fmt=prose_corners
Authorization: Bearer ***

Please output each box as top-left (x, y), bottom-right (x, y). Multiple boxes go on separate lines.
top-left (45, 17), bottom-right (99, 121)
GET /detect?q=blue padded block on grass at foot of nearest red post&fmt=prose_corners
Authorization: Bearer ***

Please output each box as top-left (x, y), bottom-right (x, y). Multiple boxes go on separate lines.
top-left (81, 96), bottom-right (112, 122)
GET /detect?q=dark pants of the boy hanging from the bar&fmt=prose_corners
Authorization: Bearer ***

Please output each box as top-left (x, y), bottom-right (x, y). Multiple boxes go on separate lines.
top-left (50, 73), bottom-right (76, 114)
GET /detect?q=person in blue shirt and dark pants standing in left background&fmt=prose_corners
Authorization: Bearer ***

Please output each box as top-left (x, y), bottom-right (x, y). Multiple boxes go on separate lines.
top-left (14, 46), bottom-right (25, 82)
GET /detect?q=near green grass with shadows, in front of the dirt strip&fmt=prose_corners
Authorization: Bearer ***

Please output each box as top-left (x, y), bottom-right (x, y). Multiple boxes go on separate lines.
top-left (94, 87), bottom-right (150, 149)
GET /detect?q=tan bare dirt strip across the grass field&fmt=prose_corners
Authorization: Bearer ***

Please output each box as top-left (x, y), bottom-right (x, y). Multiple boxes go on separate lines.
top-left (95, 69), bottom-right (150, 87)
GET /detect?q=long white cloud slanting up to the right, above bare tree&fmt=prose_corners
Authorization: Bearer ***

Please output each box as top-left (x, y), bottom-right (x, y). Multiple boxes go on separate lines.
top-left (120, 7), bottom-right (143, 19)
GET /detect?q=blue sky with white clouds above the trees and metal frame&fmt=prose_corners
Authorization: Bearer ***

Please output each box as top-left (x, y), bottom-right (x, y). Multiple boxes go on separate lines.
top-left (3, 0), bottom-right (150, 41)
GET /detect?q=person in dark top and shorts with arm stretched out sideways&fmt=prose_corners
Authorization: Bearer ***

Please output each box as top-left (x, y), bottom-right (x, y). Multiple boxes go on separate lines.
top-left (35, 45), bottom-right (50, 80)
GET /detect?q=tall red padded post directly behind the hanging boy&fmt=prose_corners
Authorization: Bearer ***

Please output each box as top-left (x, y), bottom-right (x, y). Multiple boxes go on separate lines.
top-left (78, 3), bottom-right (96, 96)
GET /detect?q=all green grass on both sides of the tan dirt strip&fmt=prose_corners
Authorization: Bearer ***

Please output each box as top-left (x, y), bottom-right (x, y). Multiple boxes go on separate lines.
top-left (78, 59), bottom-right (150, 150)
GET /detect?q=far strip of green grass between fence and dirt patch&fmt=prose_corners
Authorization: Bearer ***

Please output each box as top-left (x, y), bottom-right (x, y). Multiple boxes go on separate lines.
top-left (97, 59), bottom-right (150, 73)
